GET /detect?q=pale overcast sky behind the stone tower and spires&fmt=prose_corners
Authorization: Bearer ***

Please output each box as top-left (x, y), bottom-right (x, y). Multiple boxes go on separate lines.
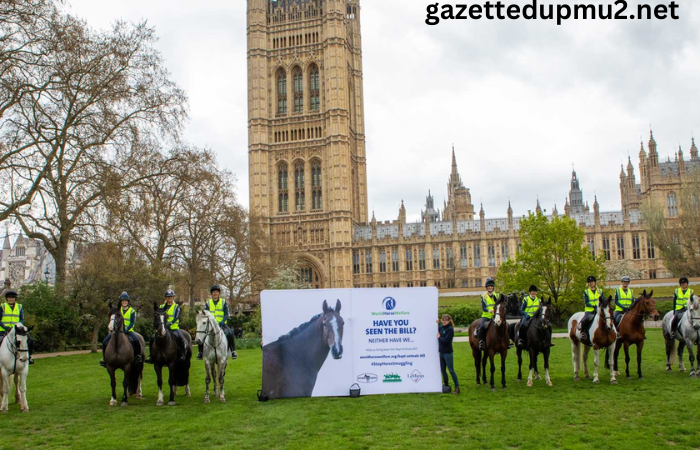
top-left (64, 0), bottom-right (700, 221)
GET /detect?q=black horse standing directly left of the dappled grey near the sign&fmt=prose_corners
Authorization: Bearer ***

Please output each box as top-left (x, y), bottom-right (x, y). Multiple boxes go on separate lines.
top-left (151, 302), bottom-right (192, 406)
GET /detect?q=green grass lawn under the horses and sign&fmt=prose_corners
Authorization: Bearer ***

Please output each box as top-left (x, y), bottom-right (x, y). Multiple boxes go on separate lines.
top-left (0, 330), bottom-right (700, 450)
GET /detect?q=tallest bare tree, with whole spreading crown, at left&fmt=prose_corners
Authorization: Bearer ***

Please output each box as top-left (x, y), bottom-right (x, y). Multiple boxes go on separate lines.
top-left (14, 18), bottom-right (186, 292)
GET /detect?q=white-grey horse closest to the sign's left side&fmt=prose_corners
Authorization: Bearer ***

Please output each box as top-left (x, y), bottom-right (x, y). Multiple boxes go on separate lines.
top-left (195, 311), bottom-right (231, 403)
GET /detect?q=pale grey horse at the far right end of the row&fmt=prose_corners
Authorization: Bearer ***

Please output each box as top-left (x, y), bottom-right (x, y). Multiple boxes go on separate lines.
top-left (663, 294), bottom-right (700, 378)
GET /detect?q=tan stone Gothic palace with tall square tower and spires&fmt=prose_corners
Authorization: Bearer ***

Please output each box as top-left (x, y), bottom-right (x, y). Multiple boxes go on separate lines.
top-left (247, 0), bottom-right (700, 288)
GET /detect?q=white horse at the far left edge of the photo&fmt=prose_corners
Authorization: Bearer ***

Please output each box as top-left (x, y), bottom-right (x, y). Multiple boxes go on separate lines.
top-left (0, 324), bottom-right (31, 413)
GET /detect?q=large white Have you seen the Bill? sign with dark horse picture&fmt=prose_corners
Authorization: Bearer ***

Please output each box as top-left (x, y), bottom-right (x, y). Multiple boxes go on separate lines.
top-left (261, 287), bottom-right (442, 398)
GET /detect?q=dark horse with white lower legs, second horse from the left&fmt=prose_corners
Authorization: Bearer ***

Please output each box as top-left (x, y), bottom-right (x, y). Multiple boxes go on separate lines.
top-left (105, 306), bottom-right (146, 406)
